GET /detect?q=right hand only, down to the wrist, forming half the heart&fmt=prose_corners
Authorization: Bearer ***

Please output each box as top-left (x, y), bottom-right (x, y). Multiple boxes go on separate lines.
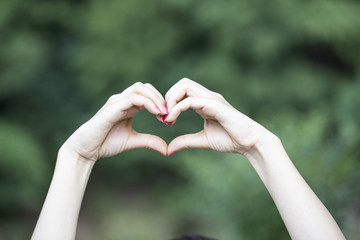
top-left (165, 79), bottom-right (267, 155)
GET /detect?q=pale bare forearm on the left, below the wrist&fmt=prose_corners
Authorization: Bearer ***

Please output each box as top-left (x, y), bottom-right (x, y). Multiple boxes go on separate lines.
top-left (32, 151), bottom-right (94, 240)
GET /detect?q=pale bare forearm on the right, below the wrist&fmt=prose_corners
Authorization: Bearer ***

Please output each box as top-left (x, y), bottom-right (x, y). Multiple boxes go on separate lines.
top-left (245, 133), bottom-right (345, 240)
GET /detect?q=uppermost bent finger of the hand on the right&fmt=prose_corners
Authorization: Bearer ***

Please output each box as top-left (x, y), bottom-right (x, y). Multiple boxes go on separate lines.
top-left (165, 78), bottom-right (212, 112)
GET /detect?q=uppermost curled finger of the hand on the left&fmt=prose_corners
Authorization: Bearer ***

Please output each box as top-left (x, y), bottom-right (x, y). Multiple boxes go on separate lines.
top-left (123, 82), bottom-right (167, 115)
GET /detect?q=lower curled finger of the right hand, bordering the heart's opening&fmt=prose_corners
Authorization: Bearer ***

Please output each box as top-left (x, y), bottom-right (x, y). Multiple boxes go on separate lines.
top-left (165, 97), bottom-right (220, 122)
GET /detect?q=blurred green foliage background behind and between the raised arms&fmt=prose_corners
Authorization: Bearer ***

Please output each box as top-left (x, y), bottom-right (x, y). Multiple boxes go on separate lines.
top-left (0, 0), bottom-right (360, 240)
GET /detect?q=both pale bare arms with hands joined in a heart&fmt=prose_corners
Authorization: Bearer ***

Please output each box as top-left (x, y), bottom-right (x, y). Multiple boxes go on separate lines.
top-left (32, 79), bottom-right (345, 240)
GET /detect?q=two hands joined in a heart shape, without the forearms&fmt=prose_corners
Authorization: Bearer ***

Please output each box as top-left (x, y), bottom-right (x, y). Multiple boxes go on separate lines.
top-left (62, 79), bottom-right (265, 161)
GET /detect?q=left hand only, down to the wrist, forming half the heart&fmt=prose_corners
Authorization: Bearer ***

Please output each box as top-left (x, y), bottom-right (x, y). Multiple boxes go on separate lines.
top-left (61, 83), bottom-right (167, 161)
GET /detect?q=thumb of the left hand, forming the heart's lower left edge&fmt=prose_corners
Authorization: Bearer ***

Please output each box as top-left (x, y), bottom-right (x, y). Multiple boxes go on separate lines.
top-left (126, 131), bottom-right (167, 156)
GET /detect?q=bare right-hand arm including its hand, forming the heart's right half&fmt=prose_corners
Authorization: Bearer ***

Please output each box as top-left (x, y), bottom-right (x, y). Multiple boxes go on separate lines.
top-left (165, 79), bottom-right (345, 240)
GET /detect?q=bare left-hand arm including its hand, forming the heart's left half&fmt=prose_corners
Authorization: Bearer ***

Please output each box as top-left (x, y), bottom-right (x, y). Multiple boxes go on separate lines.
top-left (32, 83), bottom-right (167, 240)
